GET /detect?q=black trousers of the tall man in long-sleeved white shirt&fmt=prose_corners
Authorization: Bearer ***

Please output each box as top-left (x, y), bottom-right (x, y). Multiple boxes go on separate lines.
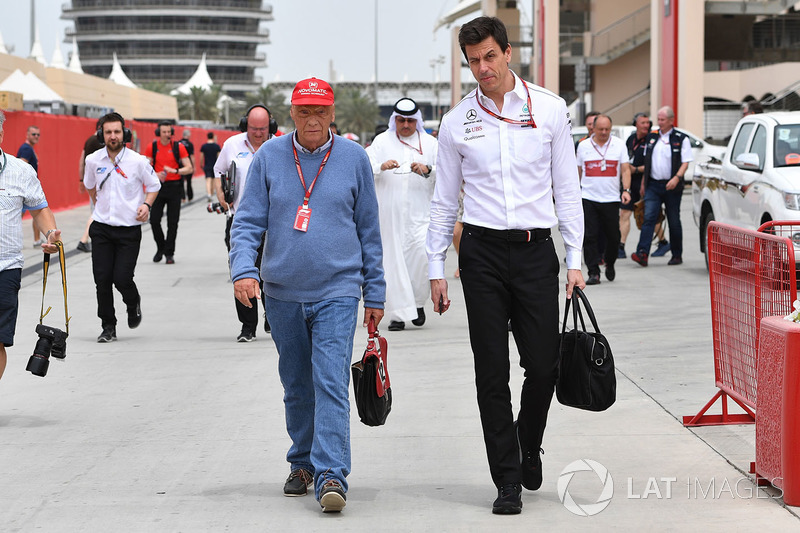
top-left (458, 226), bottom-right (560, 487)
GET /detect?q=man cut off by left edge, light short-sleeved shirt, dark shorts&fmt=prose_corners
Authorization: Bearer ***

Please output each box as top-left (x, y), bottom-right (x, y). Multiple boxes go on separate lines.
top-left (0, 111), bottom-right (61, 378)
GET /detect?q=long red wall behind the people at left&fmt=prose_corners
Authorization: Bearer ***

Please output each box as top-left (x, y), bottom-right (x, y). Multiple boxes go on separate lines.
top-left (3, 111), bottom-right (238, 212)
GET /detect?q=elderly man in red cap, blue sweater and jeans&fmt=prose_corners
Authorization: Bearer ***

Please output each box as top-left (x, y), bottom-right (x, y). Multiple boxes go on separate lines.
top-left (230, 78), bottom-right (386, 512)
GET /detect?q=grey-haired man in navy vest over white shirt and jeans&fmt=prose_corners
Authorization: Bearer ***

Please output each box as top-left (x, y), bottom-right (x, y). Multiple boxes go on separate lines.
top-left (631, 106), bottom-right (693, 266)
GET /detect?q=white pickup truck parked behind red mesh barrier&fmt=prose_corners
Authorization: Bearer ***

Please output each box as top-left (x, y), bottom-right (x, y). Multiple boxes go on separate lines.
top-left (692, 111), bottom-right (800, 265)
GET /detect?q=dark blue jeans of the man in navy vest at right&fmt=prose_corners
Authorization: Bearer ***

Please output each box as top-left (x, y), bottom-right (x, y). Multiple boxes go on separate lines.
top-left (636, 179), bottom-right (683, 257)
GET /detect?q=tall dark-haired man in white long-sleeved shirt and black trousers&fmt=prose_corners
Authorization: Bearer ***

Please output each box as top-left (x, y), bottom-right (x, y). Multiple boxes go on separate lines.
top-left (427, 17), bottom-right (585, 514)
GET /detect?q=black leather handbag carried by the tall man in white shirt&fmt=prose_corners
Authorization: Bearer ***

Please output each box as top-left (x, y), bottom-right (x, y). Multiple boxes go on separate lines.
top-left (556, 287), bottom-right (617, 411)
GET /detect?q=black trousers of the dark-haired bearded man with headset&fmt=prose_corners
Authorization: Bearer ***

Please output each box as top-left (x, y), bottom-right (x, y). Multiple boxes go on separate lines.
top-left (89, 221), bottom-right (142, 327)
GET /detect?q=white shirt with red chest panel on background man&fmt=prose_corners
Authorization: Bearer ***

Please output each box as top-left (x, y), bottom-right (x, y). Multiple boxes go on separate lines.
top-left (577, 135), bottom-right (628, 203)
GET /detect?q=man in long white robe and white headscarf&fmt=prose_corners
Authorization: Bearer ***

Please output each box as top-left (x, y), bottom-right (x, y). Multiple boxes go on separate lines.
top-left (367, 98), bottom-right (438, 331)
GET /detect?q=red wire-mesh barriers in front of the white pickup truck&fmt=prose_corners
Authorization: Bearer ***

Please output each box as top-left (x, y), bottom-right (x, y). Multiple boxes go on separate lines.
top-left (683, 222), bottom-right (797, 427)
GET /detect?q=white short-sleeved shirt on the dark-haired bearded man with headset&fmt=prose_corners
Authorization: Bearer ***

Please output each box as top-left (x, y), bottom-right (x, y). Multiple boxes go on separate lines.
top-left (83, 147), bottom-right (161, 226)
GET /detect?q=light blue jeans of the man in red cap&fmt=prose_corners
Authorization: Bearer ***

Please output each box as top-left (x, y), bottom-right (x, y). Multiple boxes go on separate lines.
top-left (266, 296), bottom-right (358, 498)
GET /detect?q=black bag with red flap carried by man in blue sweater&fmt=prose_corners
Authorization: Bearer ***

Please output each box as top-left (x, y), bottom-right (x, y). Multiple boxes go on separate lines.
top-left (350, 320), bottom-right (392, 426)
